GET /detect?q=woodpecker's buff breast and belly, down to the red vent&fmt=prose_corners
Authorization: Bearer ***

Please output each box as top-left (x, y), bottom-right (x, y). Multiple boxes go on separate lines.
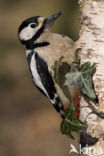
top-left (36, 34), bottom-right (76, 104)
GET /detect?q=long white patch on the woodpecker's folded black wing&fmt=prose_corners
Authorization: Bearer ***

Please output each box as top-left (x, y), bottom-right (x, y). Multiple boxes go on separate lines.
top-left (30, 55), bottom-right (49, 97)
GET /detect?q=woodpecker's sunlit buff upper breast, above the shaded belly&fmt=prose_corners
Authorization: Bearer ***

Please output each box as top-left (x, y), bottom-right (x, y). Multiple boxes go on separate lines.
top-left (36, 37), bottom-right (75, 70)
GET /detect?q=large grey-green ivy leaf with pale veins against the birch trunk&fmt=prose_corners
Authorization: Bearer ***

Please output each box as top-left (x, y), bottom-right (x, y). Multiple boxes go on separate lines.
top-left (65, 62), bottom-right (97, 100)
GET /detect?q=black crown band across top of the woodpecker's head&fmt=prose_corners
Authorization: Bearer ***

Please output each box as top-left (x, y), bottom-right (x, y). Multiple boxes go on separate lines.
top-left (18, 16), bottom-right (40, 33)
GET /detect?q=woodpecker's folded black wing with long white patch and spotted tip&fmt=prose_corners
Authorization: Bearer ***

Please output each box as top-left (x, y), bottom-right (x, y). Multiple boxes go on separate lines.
top-left (30, 53), bottom-right (64, 117)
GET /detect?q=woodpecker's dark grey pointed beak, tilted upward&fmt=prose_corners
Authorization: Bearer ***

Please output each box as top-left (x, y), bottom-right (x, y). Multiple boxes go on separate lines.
top-left (46, 11), bottom-right (62, 27)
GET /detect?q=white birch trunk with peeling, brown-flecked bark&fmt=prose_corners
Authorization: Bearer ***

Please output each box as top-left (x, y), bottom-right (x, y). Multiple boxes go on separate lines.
top-left (77, 0), bottom-right (104, 156)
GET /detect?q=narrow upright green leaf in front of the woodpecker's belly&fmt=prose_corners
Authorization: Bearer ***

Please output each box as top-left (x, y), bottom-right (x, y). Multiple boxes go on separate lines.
top-left (52, 56), bottom-right (64, 84)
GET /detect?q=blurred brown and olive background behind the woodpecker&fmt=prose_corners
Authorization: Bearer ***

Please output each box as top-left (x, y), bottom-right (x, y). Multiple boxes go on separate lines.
top-left (0, 0), bottom-right (80, 156)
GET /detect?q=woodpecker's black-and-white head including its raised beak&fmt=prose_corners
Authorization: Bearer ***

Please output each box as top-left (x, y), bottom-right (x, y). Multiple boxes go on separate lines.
top-left (18, 12), bottom-right (62, 43)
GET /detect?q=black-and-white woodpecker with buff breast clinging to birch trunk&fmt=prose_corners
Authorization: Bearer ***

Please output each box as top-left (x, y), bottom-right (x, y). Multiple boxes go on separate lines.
top-left (18, 12), bottom-right (76, 118)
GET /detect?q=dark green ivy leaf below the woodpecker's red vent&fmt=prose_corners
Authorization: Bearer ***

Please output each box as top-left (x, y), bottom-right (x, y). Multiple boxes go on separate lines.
top-left (60, 102), bottom-right (88, 139)
